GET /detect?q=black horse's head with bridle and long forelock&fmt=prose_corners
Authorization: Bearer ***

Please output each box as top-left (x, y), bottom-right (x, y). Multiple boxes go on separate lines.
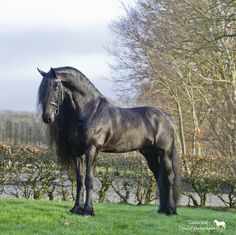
top-left (38, 69), bottom-right (64, 124)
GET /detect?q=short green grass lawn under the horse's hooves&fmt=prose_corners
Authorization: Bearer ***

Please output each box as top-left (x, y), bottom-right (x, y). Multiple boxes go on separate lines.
top-left (0, 199), bottom-right (236, 235)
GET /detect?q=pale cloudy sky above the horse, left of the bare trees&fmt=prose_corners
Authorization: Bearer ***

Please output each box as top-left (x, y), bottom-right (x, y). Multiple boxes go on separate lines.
top-left (0, 0), bottom-right (133, 111)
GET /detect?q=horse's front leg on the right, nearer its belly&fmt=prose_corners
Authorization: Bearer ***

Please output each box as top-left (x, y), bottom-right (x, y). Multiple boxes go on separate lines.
top-left (83, 146), bottom-right (97, 216)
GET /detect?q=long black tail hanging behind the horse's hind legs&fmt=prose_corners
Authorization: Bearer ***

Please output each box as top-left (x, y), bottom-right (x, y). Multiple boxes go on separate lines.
top-left (172, 140), bottom-right (181, 205)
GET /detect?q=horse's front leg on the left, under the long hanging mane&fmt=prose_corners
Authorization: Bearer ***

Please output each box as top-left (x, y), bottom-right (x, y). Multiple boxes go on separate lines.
top-left (70, 155), bottom-right (85, 215)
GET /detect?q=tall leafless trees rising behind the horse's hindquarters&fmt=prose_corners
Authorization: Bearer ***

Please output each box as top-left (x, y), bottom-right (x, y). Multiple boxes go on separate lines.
top-left (111, 0), bottom-right (236, 174)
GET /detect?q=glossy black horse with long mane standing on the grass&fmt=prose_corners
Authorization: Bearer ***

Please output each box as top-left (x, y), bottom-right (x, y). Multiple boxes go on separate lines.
top-left (38, 67), bottom-right (180, 215)
